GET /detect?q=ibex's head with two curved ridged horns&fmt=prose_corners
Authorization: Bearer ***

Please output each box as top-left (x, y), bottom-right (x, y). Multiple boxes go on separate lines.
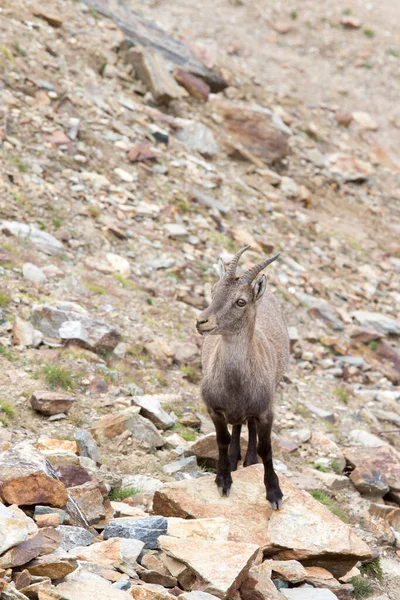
top-left (196, 246), bottom-right (279, 335)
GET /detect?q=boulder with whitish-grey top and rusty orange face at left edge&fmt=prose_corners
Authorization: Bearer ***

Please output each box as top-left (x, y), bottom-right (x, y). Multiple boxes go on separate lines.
top-left (0, 442), bottom-right (68, 507)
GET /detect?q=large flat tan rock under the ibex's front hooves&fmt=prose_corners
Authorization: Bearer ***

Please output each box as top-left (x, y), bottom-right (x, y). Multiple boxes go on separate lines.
top-left (153, 465), bottom-right (371, 576)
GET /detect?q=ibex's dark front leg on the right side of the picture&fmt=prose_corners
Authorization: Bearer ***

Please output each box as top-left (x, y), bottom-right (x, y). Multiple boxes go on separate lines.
top-left (257, 414), bottom-right (283, 509)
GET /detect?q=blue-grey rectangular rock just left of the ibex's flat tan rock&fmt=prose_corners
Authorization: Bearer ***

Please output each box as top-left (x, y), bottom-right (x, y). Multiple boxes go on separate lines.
top-left (104, 517), bottom-right (168, 550)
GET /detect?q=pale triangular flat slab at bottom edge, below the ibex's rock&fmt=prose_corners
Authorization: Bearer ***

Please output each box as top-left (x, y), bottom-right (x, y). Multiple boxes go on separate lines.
top-left (159, 536), bottom-right (259, 598)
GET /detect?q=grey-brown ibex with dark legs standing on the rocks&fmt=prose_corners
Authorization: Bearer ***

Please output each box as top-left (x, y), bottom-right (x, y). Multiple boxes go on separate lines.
top-left (196, 246), bottom-right (289, 508)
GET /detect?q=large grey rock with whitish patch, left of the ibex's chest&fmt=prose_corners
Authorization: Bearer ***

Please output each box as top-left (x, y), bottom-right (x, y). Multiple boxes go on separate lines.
top-left (32, 302), bottom-right (121, 351)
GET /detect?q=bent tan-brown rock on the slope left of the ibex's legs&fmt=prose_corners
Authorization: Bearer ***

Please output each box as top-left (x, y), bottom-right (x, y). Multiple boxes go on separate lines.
top-left (91, 406), bottom-right (165, 448)
